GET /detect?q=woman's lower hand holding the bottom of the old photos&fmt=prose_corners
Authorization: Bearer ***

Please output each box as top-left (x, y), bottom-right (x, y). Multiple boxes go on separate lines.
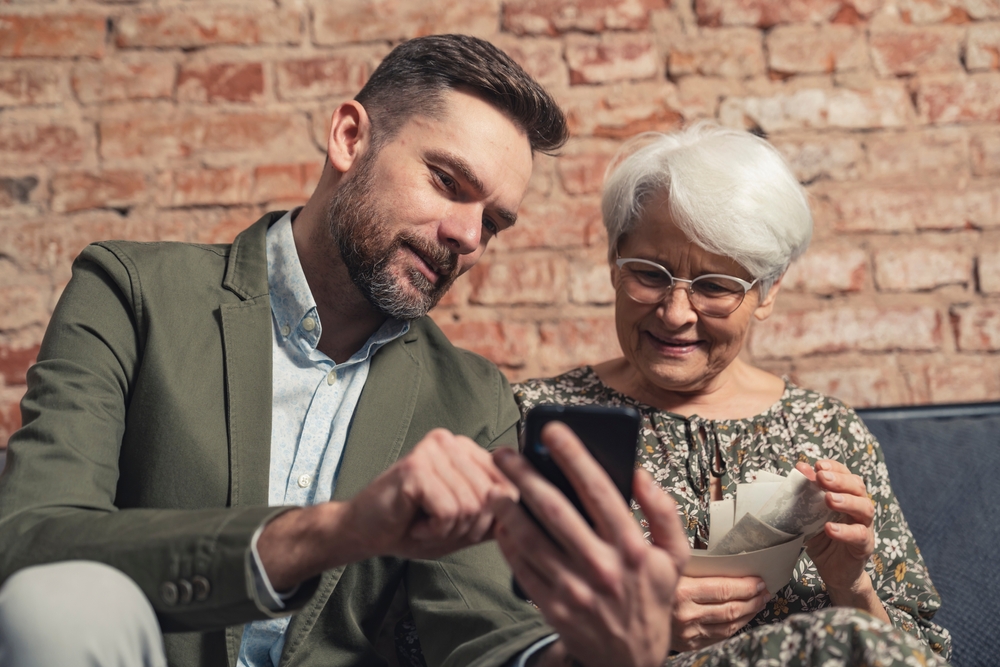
top-left (671, 577), bottom-right (771, 651)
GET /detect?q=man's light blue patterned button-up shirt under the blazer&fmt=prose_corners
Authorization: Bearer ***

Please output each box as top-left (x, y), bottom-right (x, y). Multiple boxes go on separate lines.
top-left (237, 210), bottom-right (410, 667)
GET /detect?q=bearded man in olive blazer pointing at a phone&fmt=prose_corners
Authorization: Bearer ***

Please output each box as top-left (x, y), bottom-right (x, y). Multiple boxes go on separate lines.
top-left (0, 36), bottom-right (683, 667)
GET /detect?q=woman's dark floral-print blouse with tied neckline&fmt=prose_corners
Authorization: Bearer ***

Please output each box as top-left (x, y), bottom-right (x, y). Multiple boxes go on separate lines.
top-left (514, 366), bottom-right (951, 659)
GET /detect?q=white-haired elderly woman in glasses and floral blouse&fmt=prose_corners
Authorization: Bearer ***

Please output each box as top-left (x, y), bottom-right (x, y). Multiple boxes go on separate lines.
top-left (515, 125), bottom-right (951, 664)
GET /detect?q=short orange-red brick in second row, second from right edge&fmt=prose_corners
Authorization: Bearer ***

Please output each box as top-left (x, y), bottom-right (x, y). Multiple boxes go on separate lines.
top-left (868, 26), bottom-right (965, 76)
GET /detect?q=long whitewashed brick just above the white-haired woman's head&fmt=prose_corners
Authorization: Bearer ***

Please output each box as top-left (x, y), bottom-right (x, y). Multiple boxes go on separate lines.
top-left (719, 82), bottom-right (913, 133)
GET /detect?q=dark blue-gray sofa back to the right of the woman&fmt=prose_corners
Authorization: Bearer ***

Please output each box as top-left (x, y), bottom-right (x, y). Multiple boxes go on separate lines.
top-left (858, 403), bottom-right (1000, 667)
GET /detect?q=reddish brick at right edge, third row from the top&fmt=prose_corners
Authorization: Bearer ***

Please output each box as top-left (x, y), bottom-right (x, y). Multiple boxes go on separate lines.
top-left (917, 73), bottom-right (1000, 124)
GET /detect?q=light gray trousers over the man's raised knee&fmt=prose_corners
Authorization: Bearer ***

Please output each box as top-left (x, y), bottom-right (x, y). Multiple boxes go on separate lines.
top-left (0, 561), bottom-right (167, 667)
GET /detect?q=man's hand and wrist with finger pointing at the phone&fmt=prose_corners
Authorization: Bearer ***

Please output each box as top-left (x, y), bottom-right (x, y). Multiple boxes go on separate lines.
top-left (257, 429), bottom-right (518, 590)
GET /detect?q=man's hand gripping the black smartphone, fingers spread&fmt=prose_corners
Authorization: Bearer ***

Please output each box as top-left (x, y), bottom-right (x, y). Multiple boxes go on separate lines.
top-left (494, 422), bottom-right (688, 667)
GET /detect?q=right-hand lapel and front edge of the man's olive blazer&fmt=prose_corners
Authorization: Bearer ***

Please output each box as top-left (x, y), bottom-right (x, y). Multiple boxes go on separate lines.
top-left (281, 331), bottom-right (420, 665)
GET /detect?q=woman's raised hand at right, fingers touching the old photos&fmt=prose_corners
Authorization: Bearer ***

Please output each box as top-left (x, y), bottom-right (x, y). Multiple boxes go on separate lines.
top-left (796, 459), bottom-right (889, 621)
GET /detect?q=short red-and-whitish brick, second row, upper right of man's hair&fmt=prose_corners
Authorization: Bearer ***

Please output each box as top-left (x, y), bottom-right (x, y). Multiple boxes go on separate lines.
top-left (566, 33), bottom-right (660, 85)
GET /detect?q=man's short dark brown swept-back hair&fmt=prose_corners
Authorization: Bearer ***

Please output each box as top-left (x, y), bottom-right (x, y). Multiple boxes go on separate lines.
top-left (354, 35), bottom-right (568, 154)
